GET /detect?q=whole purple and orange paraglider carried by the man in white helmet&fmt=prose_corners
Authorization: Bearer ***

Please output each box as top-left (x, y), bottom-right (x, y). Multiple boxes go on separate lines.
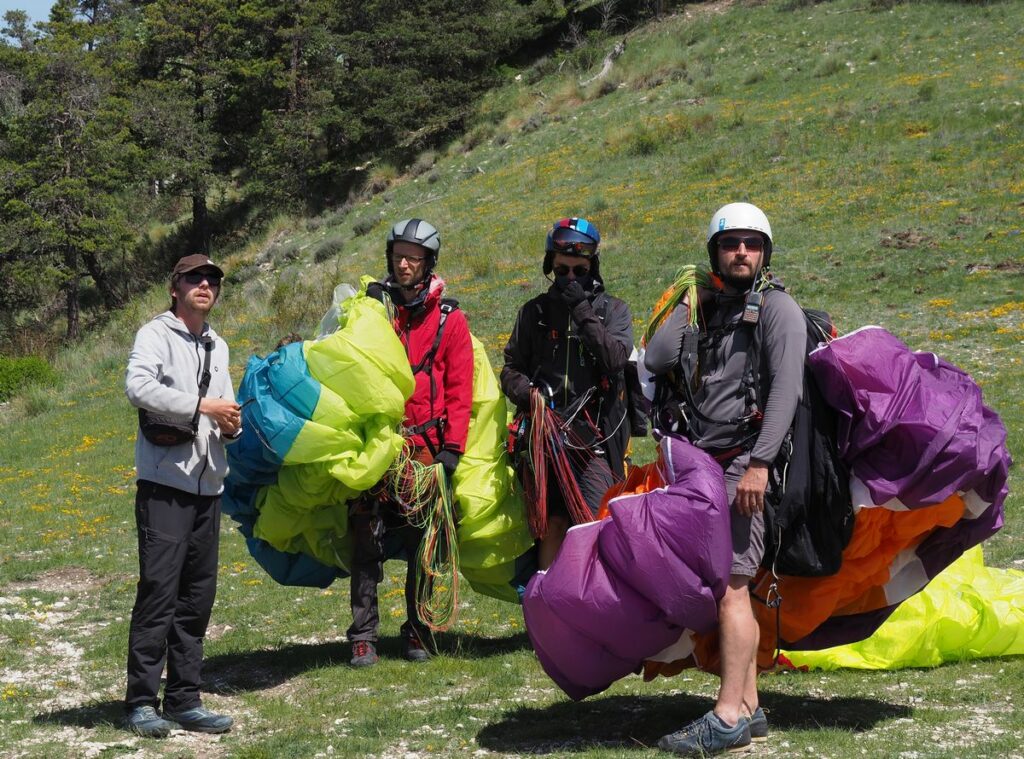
top-left (523, 327), bottom-right (1011, 699)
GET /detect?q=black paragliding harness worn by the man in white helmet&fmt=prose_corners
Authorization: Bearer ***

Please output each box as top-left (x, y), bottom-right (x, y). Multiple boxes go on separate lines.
top-left (654, 280), bottom-right (853, 577)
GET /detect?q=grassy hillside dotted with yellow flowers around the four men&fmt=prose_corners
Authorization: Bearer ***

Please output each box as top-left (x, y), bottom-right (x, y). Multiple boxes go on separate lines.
top-left (0, 0), bottom-right (1024, 759)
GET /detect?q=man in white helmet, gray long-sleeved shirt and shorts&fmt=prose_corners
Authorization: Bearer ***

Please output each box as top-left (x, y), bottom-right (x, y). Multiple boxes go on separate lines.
top-left (644, 203), bottom-right (807, 756)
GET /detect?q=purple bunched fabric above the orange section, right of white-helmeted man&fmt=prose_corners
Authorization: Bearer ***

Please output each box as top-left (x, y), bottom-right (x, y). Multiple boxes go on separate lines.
top-left (808, 327), bottom-right (1010, 508)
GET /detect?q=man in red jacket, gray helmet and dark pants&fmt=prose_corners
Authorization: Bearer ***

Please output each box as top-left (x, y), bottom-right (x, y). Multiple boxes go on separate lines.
top-left (347, 219), bottom-right (473, 667)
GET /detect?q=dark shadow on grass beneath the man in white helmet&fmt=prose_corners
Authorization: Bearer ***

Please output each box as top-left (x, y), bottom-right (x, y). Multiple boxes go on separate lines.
top-left (476, 690), bottom-right (910, 755)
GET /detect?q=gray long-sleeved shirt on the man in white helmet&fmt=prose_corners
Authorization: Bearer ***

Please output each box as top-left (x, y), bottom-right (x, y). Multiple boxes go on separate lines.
top-left (644, 290), bottom-right (807, 462)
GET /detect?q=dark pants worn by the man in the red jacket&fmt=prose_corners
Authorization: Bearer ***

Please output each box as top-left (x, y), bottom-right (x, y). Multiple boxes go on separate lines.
top-left (345, 499), bottom-right (429, 643)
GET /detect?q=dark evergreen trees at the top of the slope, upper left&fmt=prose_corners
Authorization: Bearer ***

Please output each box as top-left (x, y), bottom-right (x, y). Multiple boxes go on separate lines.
top-left (0, 0), bottom-right (566, 342)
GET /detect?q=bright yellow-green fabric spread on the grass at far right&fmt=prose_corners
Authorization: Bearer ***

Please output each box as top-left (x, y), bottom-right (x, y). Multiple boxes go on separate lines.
top-left (783, 546), bottom-right (1024, 670)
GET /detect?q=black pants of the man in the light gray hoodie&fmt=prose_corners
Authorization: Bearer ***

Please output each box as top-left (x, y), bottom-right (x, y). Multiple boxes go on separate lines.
top-left (125, 480), bottom-right (220, 712)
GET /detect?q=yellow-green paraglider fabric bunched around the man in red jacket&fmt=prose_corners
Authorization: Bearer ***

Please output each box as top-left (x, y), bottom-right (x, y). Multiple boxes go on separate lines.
top-left (253, 286), bottom-right (534, 602)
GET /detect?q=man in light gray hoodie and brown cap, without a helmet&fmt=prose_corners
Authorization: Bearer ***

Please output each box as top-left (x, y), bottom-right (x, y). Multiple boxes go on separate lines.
top-left (125, 253), bottom-right (242, 737)
